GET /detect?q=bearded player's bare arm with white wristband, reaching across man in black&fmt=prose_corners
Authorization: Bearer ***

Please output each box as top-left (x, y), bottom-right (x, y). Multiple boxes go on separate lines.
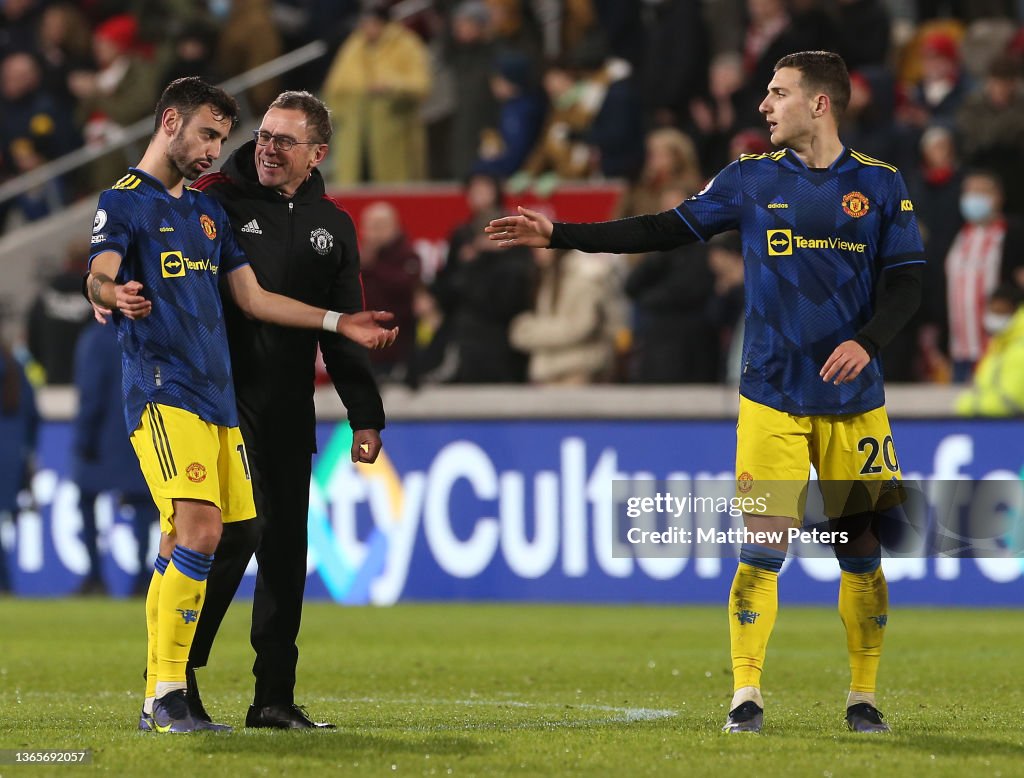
top-left (227, 265), bottom-right (398, 348)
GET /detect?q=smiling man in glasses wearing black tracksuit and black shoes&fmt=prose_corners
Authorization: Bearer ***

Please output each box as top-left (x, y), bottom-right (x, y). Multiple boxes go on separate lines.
top-left (188, 92), bottom-right (384, 729)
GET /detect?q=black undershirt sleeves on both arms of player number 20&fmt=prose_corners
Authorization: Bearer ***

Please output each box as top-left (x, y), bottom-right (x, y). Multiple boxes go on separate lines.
top-left (550, 210), bottom-right (924, 358)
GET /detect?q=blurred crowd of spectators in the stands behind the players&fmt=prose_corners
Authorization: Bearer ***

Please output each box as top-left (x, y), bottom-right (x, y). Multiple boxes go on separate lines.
top-left (6, 0), bottom-right (1024, 397)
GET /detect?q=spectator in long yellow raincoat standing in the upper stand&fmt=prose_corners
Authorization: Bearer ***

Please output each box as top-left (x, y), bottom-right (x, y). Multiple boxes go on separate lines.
top-left (324, 4), bottom-right (431, 184)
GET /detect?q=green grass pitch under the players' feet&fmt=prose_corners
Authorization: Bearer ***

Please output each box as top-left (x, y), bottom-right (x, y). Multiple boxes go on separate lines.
top-left (0, 599), bottom-right (1024, 778)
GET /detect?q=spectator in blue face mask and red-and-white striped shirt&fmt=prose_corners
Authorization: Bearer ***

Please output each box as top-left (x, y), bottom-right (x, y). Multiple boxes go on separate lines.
top-left (945, 171), bottom-right (1024, 382)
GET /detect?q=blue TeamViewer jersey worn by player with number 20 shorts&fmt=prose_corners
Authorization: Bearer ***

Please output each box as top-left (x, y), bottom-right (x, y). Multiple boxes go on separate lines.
top-left (676, 149), bottom-right (925, 416)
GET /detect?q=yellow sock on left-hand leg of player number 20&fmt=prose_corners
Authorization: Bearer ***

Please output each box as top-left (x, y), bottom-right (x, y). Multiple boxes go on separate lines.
top-left (729, 562), bottom-right (778, 691)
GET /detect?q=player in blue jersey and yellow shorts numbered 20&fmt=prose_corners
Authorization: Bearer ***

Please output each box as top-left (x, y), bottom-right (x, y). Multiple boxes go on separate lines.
top-left (485, 51), bottom-right (925, 732)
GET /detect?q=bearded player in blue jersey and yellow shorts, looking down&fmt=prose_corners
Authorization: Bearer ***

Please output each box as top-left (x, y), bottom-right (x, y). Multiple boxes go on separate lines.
top-left (87, 78), bottom-right (396, 732)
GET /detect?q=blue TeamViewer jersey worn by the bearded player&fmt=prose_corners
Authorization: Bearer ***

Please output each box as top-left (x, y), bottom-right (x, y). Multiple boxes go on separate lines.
top-left (90, 168), bottom-right (248, 432)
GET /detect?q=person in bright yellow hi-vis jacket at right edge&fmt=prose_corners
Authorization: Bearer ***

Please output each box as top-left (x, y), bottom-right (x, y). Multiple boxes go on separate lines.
top-left (956, 285), bottom-right (1024, 416)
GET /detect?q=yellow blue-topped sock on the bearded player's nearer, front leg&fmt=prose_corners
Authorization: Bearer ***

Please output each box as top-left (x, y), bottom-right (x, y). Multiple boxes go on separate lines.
top-left (157, 546), bottom-right (213, 690)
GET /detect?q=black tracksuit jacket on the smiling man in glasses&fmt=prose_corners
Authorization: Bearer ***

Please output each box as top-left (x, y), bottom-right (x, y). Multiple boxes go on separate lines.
top-left (195, 141), bottom-right (384, 452)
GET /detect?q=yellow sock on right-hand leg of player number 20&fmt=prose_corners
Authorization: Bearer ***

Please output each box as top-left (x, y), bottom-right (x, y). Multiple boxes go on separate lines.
top-left (839, 566), bottom-right (889, 693)
